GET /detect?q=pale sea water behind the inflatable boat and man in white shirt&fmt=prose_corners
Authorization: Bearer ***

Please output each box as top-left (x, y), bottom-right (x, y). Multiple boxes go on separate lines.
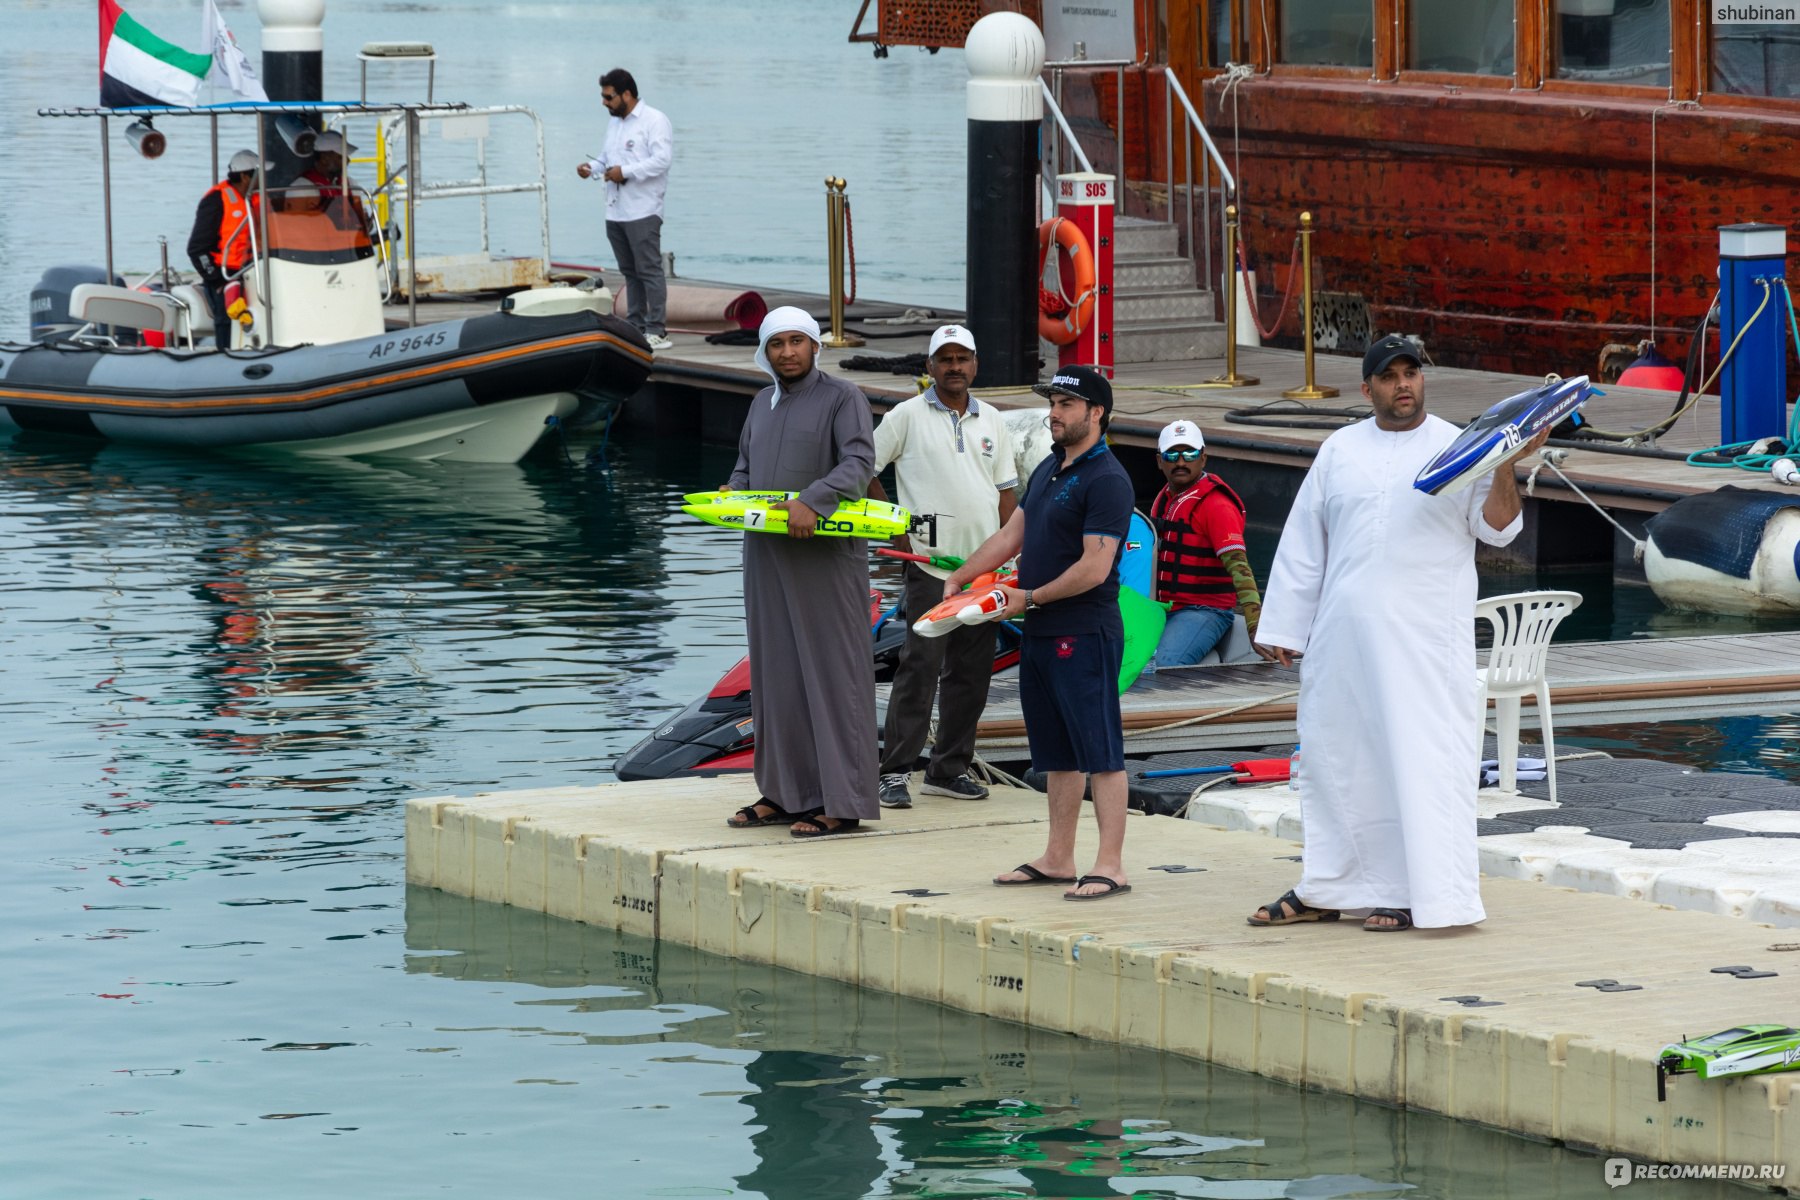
top-left (0, 0), bottom-right (968, 338)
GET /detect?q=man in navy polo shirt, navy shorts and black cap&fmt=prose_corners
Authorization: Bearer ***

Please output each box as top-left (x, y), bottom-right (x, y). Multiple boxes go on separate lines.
top-left (943, 367), bottom-right (1132, 900)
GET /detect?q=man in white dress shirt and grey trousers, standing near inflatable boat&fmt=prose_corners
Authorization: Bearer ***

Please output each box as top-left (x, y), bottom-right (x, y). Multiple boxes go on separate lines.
top-left (576, 67), bottom-right (675, 351)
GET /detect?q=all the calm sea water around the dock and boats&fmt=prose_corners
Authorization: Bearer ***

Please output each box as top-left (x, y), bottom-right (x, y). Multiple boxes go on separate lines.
top-left (0, 0), bottom-right (1793, 1200)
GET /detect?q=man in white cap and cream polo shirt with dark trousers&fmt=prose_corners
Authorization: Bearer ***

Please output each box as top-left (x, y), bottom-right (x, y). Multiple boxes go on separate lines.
top-left (869, 326), bottom-right (1017, 808)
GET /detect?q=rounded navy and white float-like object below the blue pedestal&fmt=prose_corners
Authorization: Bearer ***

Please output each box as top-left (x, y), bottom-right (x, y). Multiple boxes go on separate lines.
top-left (1643, 488), bottom-right (1800, 615)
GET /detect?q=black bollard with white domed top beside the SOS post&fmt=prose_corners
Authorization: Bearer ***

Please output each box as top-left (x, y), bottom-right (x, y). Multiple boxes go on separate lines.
top-left (963, 13), bottom-right (1044, 387)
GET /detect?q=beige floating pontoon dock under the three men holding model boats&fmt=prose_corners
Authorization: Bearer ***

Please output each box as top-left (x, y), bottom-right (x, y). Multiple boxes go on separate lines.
top-left (407, 777), bottom-right (1800, 1187)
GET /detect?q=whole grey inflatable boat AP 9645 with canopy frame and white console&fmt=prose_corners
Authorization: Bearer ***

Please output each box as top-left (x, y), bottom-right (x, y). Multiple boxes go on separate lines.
top-left (19, 104), bottom-right (652, 462)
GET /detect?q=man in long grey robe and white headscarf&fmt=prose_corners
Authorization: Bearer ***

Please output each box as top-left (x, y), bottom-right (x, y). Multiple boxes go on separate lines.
top-left (725, 308), bottom-right (882, 838)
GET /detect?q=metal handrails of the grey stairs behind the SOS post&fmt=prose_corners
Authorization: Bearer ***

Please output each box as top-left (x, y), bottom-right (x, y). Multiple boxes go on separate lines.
top-left (1040, 59), bottom-right (1237, 300)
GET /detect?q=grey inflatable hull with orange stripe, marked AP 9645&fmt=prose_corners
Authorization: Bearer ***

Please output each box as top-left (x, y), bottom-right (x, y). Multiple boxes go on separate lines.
top-left (0, 298), bottom-right (652, 462)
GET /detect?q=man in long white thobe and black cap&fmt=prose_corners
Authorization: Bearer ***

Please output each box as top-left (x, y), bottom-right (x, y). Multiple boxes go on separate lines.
top-left (1249, 336), bottom-right (1543, 932)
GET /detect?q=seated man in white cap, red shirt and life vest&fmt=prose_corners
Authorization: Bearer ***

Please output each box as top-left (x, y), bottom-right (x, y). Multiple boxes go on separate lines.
top-left (1150, 421), bottom-right (1274, 667)
